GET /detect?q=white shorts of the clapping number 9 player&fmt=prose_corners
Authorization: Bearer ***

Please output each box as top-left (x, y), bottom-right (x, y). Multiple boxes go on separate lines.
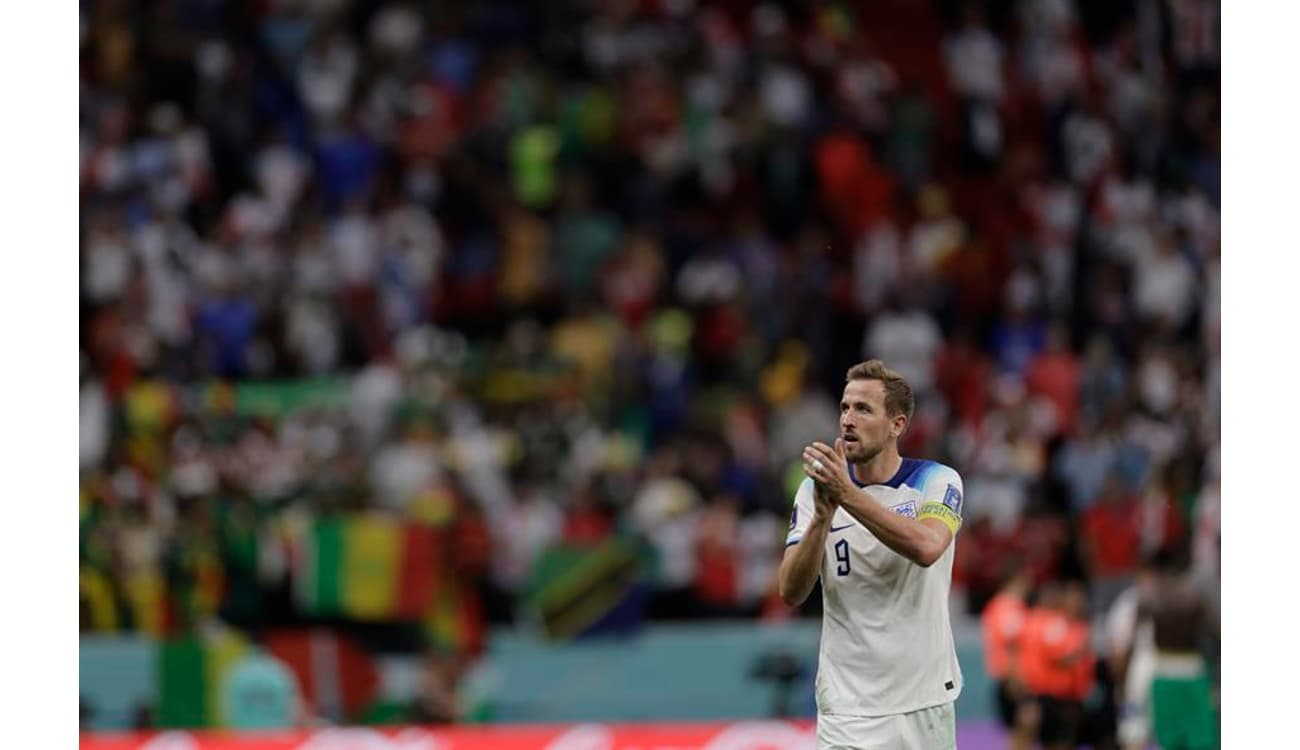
top-left (816, 703), bottom-right (957, 750)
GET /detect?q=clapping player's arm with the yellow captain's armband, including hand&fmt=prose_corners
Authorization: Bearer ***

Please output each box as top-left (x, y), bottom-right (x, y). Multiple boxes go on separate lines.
top-left (803, 441), bottom-right (961, 568)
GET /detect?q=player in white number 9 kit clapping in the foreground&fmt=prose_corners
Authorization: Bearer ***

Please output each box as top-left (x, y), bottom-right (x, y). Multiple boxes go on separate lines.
top-left (780, 360), bottom-right (962, 750)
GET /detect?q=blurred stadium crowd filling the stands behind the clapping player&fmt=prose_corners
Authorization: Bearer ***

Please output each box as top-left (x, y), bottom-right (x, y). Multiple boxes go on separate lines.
top-left (81, 0), bottom-right (1219, 738)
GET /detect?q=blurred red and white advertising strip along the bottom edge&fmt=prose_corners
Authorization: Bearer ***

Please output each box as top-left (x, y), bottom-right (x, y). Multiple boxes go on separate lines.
top-left (81, 721), bottom-right (816, 750)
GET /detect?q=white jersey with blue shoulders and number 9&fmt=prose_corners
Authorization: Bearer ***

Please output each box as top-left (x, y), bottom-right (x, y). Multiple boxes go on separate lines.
top-left (785, 459), bottom-right (962, 716)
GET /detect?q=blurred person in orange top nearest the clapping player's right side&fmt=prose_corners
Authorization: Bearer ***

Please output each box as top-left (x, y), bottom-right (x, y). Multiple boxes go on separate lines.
top-left (967, 558), bottom-right (1039, 750)
